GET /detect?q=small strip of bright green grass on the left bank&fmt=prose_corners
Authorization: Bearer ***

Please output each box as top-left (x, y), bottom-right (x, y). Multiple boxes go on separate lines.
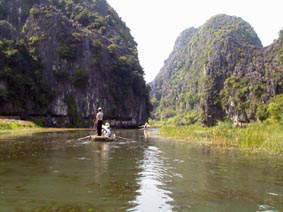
top-left (0, 119), bottom-right (39, 130)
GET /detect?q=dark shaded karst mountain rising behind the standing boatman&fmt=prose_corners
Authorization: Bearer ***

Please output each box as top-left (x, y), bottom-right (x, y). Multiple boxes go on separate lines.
top-left (0, 0), bottom-right (150, 127)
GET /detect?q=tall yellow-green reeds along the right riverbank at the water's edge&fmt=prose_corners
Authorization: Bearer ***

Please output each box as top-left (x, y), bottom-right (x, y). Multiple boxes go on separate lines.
top-left (160, 122), bottom-right (283, 154)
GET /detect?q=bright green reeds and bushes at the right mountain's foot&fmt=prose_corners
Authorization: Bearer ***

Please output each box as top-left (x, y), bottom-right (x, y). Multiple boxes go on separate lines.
top-left (155, 94), bottom-right (283, 153)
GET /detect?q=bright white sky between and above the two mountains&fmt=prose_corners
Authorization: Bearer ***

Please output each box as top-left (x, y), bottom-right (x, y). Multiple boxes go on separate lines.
top-left (108, 0), bottom-right (283, 82)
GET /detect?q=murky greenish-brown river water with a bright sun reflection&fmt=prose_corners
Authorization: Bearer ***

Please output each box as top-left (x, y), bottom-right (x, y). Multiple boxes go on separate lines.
top-left (0, 130), bottom-right (283, 212)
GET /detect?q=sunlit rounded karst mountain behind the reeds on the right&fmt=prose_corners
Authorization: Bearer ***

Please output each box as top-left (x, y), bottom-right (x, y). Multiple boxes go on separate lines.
top-left (151, 15), bottom-right (283, 125)
